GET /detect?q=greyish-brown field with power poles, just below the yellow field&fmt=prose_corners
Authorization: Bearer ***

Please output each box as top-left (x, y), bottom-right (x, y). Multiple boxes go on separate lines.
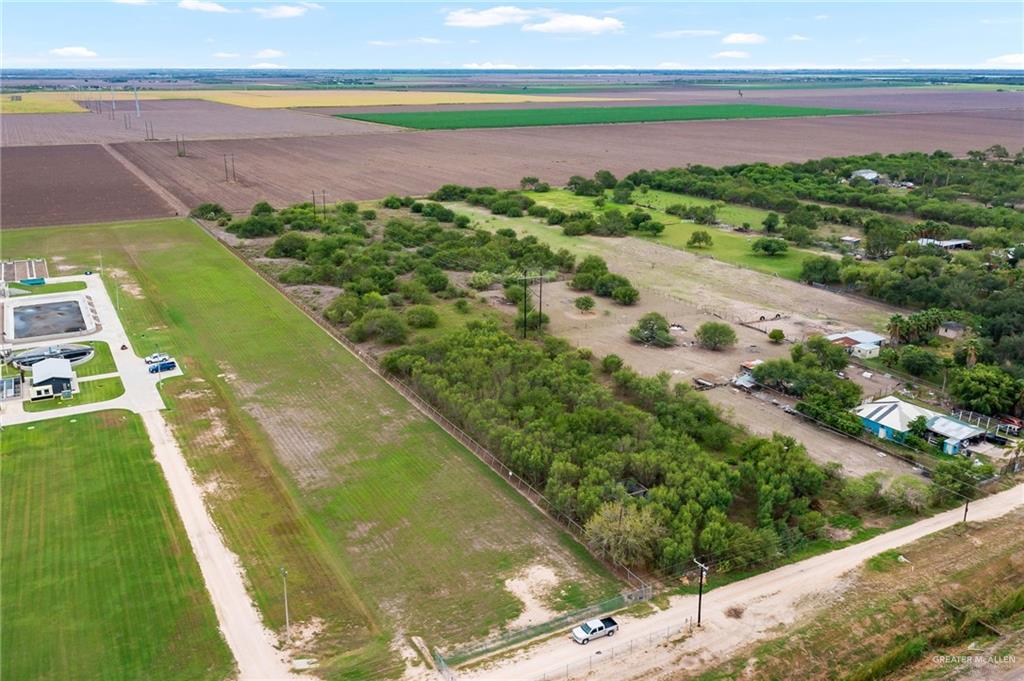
top-left (0, 99), bottom-right (393, 146)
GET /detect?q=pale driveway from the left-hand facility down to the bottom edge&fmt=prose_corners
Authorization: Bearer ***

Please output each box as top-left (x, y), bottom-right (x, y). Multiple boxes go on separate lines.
top-left (0, 274), bottom-right (299, 680)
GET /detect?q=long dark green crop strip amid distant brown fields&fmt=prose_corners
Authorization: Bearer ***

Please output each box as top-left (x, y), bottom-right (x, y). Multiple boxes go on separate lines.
top-left (339, 104), bottom-right (869, 130)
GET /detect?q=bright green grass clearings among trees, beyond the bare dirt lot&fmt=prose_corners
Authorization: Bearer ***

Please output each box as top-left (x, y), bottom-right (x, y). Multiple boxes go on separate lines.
top-left (517, 189), bottom-right (817, 281)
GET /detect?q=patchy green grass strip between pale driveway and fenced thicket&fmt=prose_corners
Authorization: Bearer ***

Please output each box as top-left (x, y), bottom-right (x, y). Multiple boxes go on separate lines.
top-left (4, 220), bottom-right (618, 679)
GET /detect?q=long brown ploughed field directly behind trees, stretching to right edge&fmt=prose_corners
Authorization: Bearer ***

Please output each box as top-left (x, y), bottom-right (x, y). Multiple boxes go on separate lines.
top-left (110, 110), bottom-right (1024, 210)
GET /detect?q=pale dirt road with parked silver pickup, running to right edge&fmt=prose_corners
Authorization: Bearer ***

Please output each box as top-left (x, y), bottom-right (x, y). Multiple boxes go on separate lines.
top-left (458, 485), bottom-right (1024, 681)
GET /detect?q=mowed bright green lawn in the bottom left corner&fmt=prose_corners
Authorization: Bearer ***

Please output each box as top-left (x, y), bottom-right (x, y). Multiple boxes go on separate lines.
top-left (0, 411), bottom-right (234, 681)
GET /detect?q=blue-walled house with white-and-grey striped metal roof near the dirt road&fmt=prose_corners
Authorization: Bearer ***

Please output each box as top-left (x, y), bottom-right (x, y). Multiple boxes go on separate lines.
top-left (853, 397), bottom-right (985, 455)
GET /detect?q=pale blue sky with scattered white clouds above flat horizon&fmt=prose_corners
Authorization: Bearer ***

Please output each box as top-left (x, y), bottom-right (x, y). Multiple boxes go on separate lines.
top-left (0, 0), bottom-right (1024, 70)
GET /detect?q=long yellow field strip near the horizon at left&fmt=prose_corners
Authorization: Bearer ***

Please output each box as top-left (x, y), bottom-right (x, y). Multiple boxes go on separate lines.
top-left (0, 90), bottom-right (630, 114)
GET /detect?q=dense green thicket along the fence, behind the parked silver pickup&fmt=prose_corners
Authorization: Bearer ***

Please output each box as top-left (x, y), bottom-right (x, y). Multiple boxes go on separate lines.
top-left (384, 323), bottom-right (824, 566)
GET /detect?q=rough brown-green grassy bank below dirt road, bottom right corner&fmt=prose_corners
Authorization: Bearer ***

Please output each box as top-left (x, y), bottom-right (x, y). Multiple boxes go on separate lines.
top-left (675, 511), bottom-right (1024, 681)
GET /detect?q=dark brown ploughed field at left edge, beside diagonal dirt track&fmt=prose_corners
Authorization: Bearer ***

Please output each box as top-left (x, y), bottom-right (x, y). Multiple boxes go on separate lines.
top-left (0, 143), bottom-right (174, 227)
